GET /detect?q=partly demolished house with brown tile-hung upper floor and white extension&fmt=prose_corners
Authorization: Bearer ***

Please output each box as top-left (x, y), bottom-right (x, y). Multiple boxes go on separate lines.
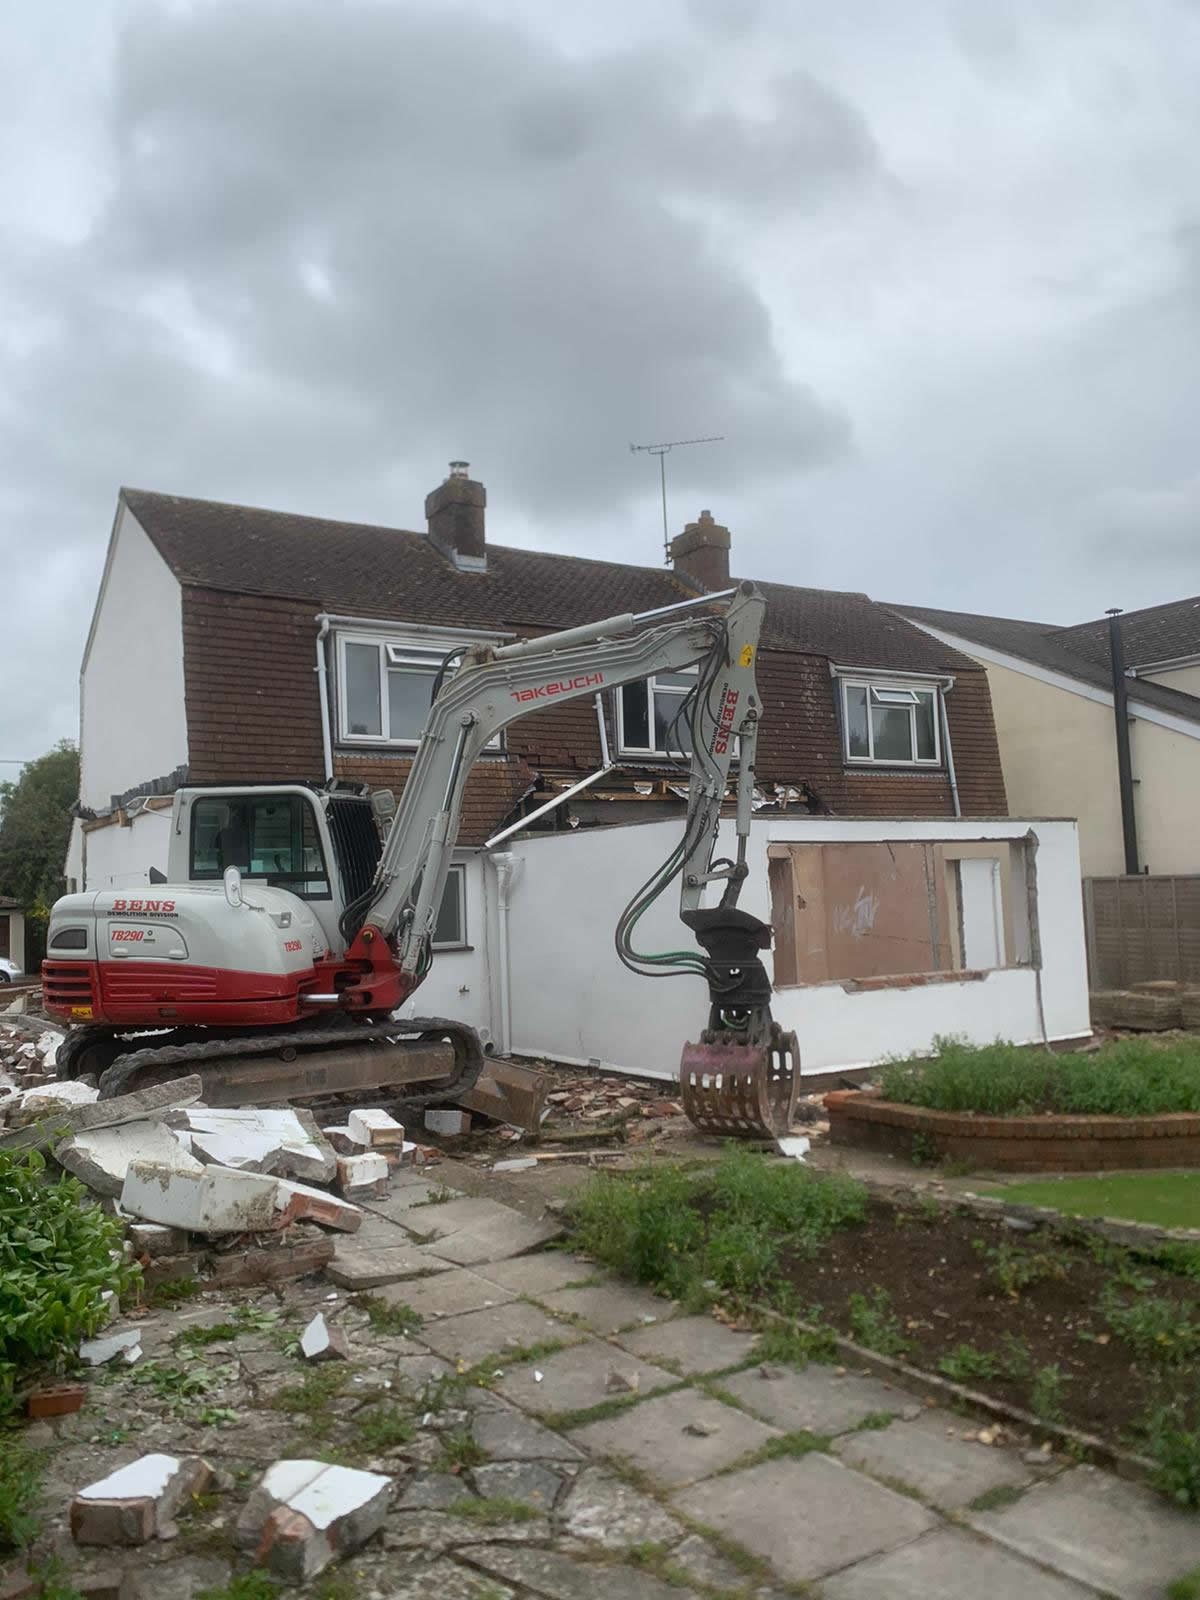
top-left (67, 462), bottom-right (1086, 1070)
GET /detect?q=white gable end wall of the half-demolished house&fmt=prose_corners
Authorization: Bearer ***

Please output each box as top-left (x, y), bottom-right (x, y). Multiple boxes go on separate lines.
top-left (80, 506), bottom-right (187, 812)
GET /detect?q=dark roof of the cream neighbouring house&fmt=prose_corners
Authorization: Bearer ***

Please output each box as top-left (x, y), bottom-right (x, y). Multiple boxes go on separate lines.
top-left (891, 600), bottom-right (1200, 722)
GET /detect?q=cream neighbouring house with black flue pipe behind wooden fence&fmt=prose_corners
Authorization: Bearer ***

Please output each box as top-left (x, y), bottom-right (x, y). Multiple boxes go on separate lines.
top-left (893, 597), bottom-right (1200, 877)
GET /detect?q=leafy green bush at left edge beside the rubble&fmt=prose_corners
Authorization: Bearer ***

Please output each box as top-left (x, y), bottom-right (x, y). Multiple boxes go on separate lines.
top-left (0, 1150), bottom-right (141, 1418)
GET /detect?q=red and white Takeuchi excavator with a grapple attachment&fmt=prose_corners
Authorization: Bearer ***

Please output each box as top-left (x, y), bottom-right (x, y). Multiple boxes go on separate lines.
top-left (42, 582), bottom-right (798, 1138)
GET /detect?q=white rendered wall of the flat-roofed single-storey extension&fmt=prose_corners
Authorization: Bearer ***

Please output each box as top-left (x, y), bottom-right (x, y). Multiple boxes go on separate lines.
top-left (492, 818), bottom-right (1090, 1078)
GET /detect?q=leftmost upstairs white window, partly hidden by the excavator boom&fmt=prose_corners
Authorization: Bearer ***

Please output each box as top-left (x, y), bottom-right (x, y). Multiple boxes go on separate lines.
top-left (338, 634), bottom-right (499, 749)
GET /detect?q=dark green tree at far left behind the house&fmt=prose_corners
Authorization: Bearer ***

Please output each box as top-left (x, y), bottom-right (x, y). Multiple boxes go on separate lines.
top-left (0, 739), bottom-right (78, 970)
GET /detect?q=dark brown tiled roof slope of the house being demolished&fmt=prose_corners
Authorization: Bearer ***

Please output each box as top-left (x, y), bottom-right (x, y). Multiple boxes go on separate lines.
top-left (122, 488), bottom-right (968, 672)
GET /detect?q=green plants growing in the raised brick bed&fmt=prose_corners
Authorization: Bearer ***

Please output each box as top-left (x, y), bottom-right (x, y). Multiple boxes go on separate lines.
top-left (880, 1038), bottom-right (1200, 1117)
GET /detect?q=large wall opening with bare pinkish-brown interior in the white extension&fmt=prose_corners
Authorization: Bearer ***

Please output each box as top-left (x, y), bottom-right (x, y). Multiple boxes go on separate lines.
top-left (770, 840), bottom-right (1030, 986)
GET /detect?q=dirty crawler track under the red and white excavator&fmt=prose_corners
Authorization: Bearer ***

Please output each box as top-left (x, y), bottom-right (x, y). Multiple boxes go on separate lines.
top-left (89, 1016), bottom-right (483, 1112)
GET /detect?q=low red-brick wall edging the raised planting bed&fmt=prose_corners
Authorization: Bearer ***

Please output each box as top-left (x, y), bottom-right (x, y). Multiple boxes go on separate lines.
top-left (824, 1090), bottom-right (1200, 1173)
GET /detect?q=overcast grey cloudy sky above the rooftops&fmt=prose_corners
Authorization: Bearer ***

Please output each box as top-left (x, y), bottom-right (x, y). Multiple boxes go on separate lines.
top-left (0, 0), bottom-right (1200, 776)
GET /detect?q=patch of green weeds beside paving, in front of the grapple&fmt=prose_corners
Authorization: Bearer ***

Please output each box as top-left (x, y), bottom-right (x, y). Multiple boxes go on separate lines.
top-left (571, 1149), bottom-right (867, 1306)
